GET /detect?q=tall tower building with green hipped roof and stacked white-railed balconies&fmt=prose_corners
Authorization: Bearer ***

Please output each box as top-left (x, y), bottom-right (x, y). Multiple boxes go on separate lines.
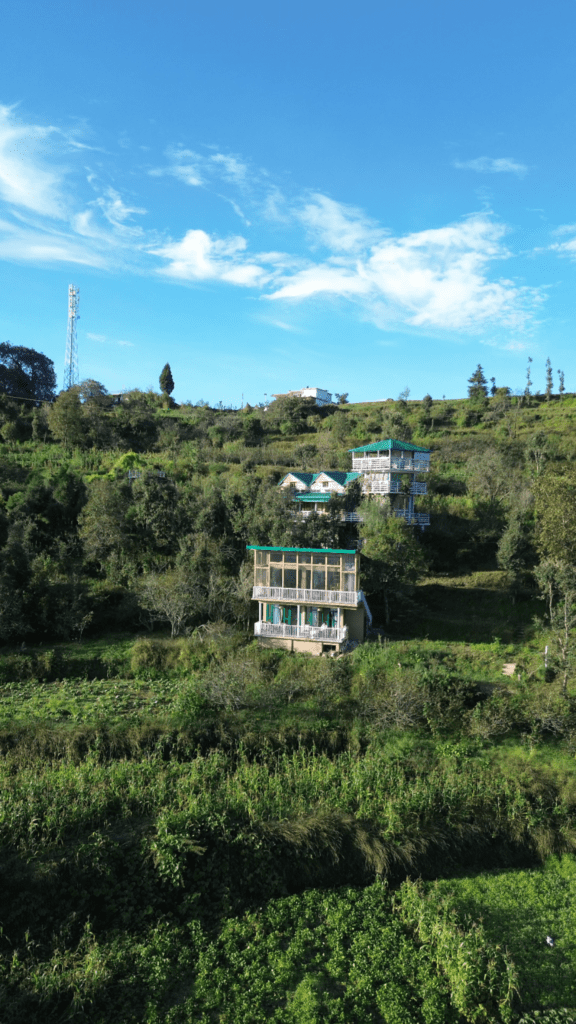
top-left (348, 437), bottom-right (430, 526)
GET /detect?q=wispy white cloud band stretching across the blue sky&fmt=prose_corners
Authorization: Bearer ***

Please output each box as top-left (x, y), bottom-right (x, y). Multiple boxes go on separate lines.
top-left (0, 108), bottom-right (545, 344)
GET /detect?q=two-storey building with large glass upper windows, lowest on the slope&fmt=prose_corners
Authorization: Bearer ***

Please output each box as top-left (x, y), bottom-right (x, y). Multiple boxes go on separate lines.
top-left (247, 544), bottom-right (372, 654)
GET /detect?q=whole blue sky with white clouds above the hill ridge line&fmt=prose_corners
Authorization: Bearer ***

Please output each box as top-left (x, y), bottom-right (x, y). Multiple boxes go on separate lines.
top-left (0, 0), bottom-right (576, 406)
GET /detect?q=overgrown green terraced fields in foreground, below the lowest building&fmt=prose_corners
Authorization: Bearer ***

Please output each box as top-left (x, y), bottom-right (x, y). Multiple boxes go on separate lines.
top-left (0, 610), bottom-right (576, 1024)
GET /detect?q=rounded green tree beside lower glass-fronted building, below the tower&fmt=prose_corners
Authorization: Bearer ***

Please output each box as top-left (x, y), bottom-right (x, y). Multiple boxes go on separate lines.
top-left (358, 499), bottom-right (426, 626)
